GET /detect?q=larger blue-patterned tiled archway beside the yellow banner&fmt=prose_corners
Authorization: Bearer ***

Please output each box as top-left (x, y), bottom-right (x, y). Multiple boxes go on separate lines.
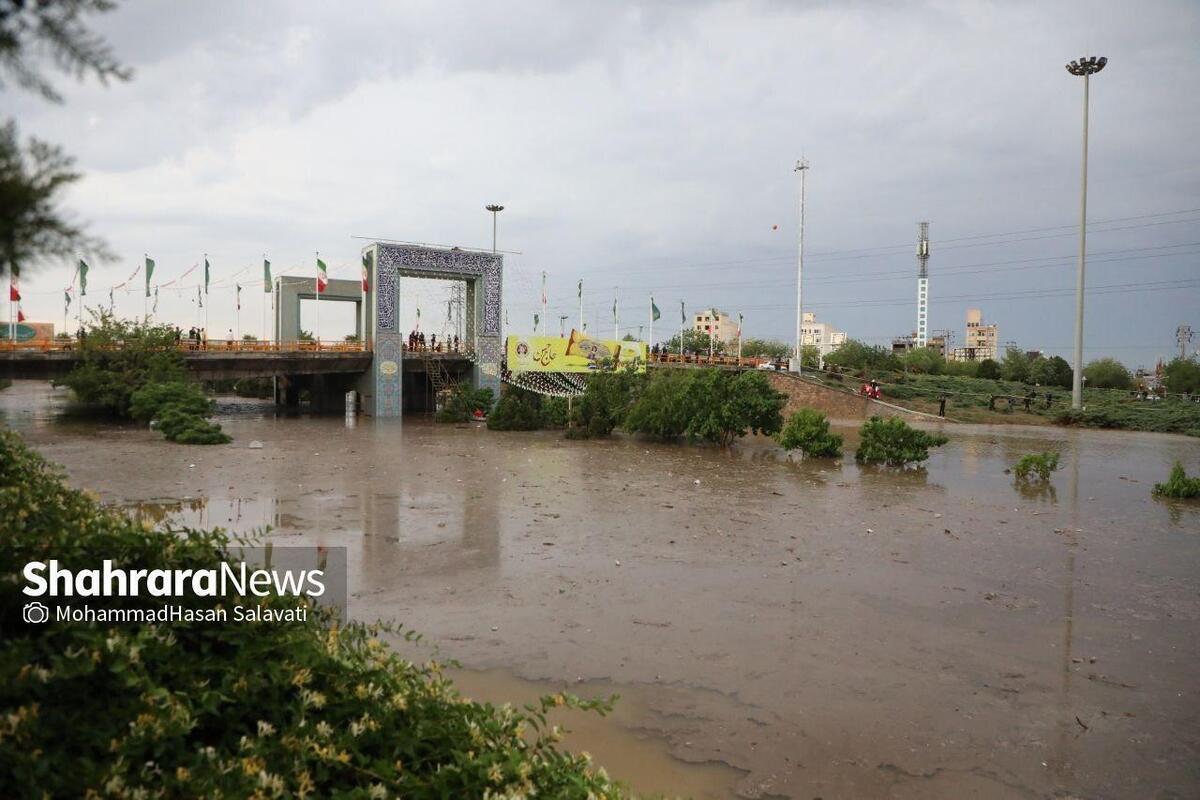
top-left (359, 242), bottom-right (504, 416)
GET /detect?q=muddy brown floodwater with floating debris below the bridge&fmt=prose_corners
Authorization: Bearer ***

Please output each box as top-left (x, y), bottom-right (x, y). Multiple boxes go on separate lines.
top-left (0, 383), bottom-right (1200, 800)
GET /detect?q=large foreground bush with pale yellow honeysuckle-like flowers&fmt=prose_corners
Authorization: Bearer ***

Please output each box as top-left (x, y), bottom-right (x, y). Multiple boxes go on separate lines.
top-left (0, 431), bottom-right (623, 798)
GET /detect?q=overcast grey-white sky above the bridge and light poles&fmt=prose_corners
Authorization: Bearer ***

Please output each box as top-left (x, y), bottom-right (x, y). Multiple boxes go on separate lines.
top-left (9, 1), bottom-right (1200, 366)
